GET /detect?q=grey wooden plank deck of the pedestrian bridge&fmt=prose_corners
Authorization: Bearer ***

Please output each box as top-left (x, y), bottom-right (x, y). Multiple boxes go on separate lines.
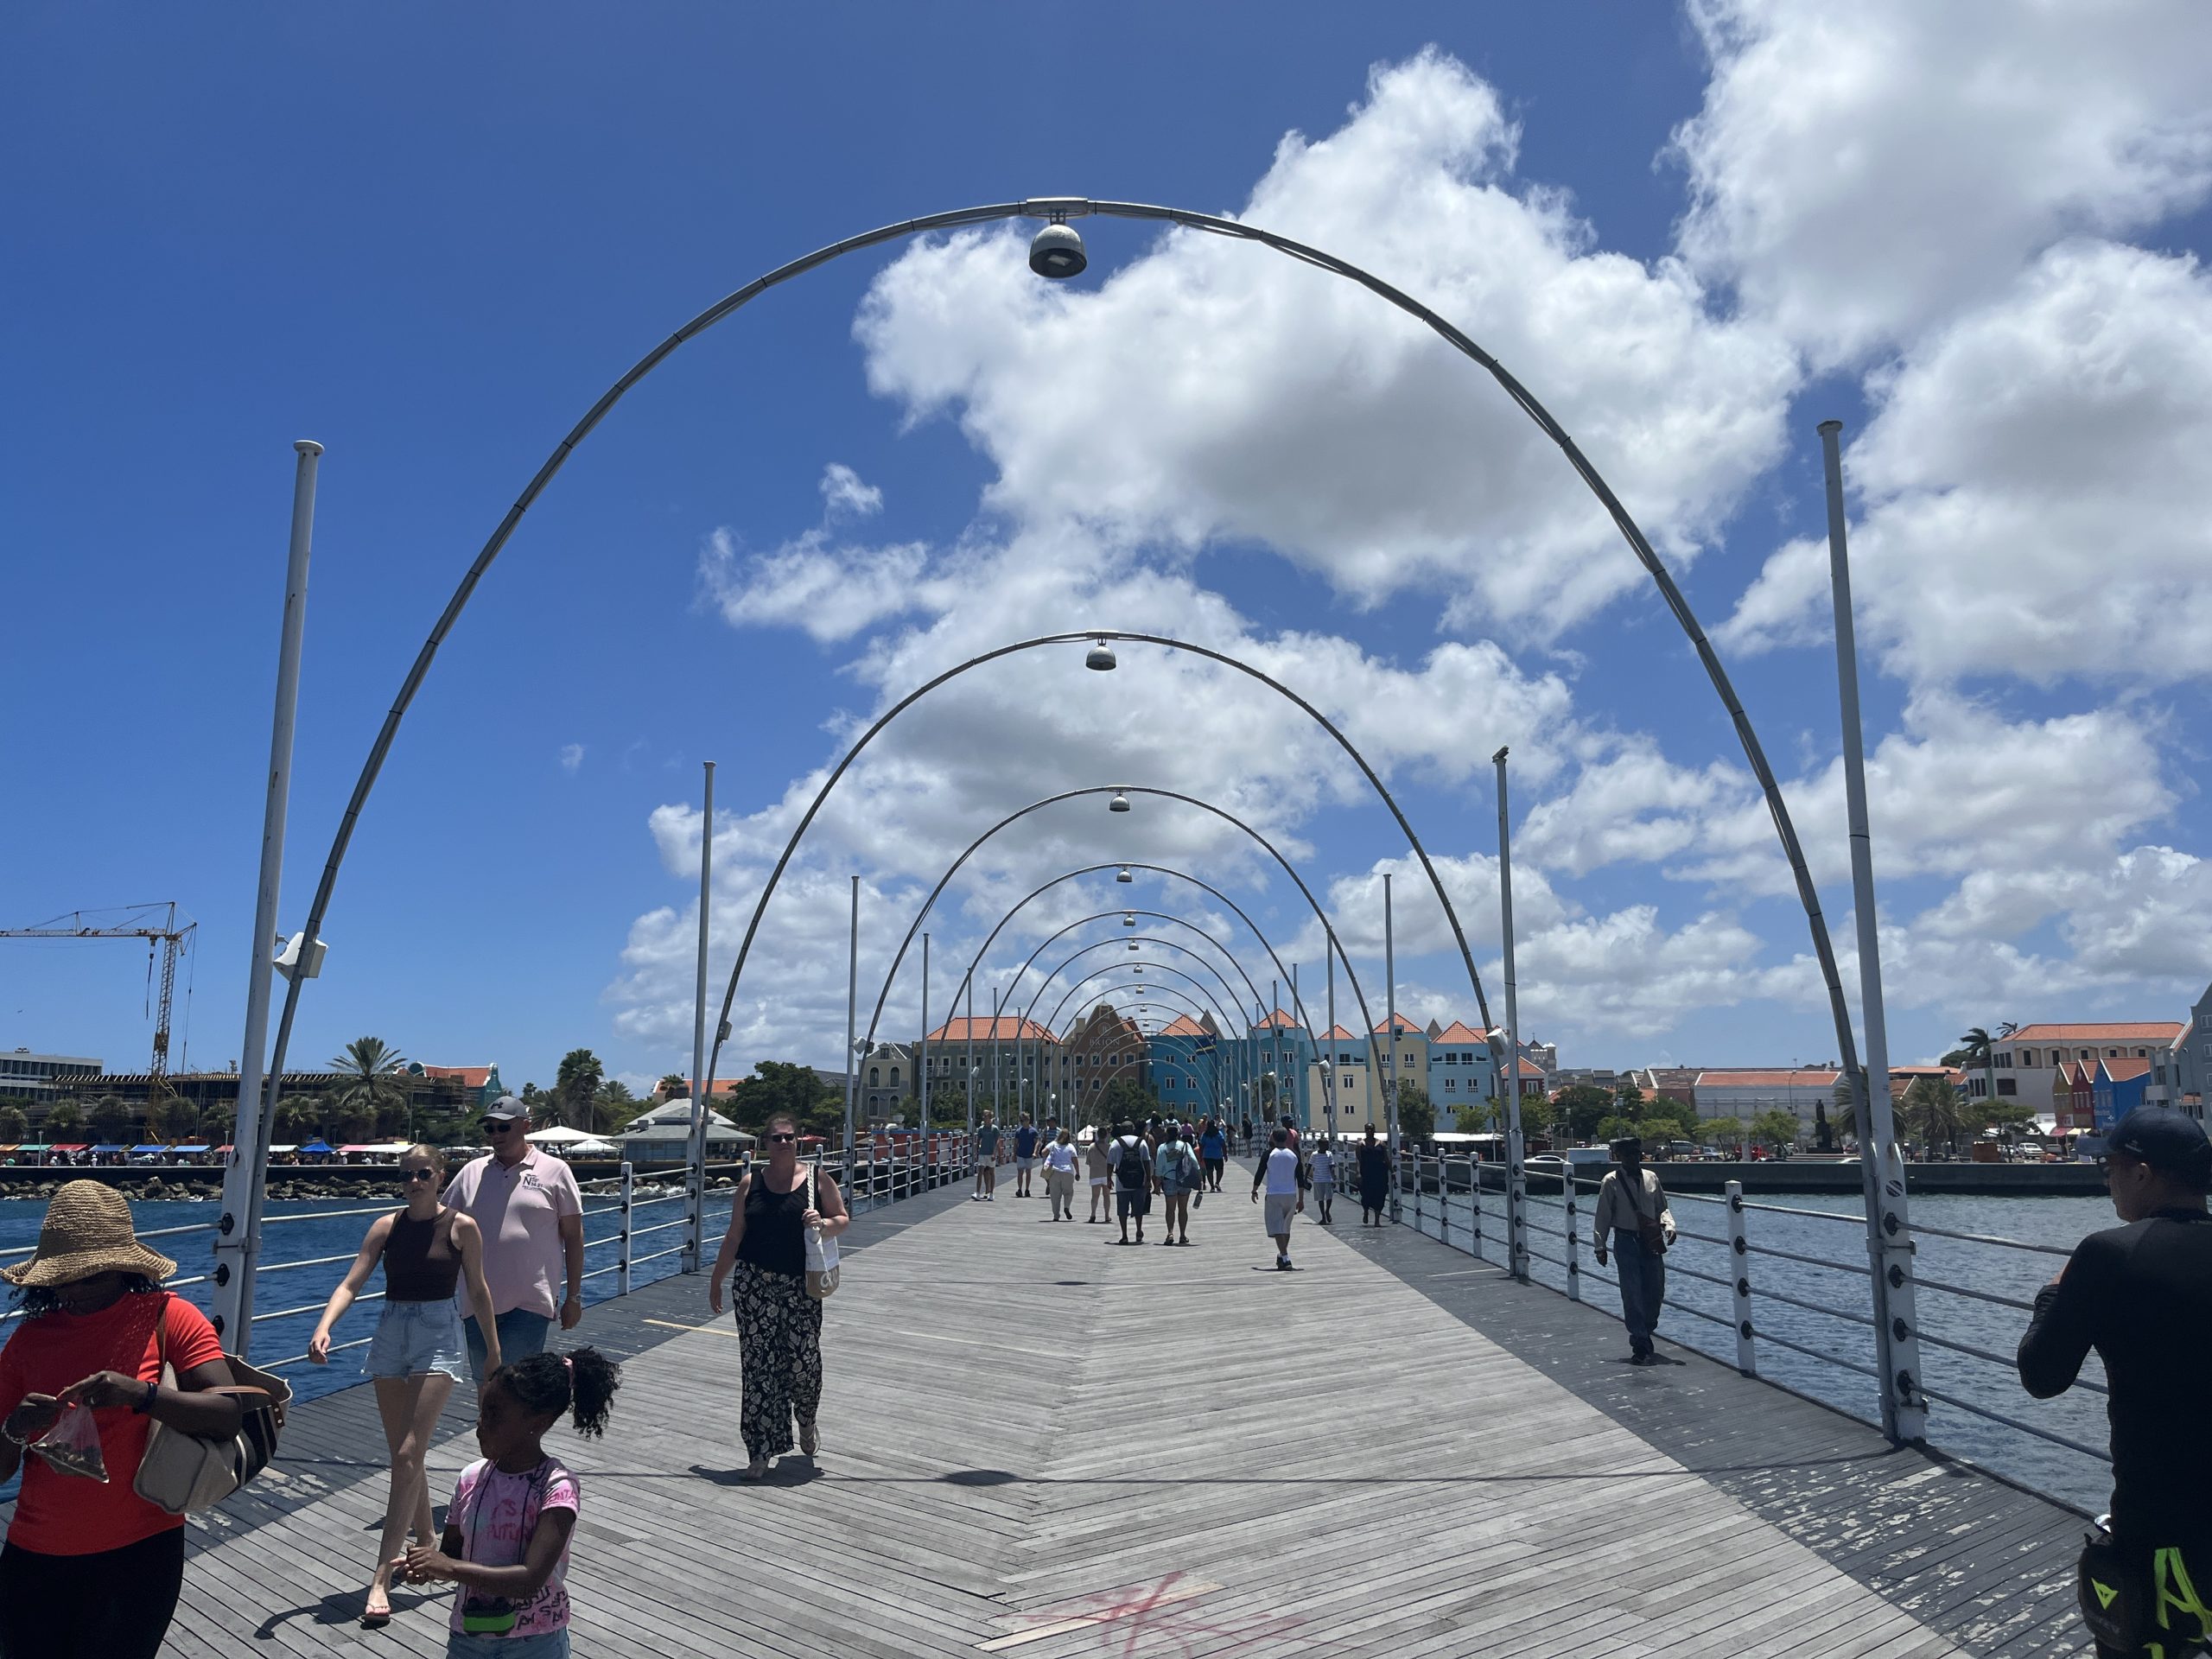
top-left (69, 1174), bottom-right (2086, 1659)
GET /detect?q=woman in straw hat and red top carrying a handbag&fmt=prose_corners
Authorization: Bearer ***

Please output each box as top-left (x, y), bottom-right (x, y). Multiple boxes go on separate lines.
top-left (0, 1181), bottom-right (244, 1659)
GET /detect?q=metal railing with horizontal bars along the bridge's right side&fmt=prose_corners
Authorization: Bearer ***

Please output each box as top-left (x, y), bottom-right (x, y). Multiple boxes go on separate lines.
top-left (1395, 1150), bottom-right (2113, 1503)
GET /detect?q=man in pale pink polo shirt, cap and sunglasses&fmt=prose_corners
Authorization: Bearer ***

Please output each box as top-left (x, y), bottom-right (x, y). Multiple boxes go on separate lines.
top-left (445, 1095), bottom-right (584, 1385)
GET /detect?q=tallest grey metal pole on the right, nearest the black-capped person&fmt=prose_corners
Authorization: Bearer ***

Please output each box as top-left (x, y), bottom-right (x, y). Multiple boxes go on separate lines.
top-left (1821, 420), bottom-right (1929, 1440)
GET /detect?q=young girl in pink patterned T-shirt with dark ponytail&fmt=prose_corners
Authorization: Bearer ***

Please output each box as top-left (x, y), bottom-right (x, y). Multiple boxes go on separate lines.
top-left (391, 1347), bottom-right (621, 1659)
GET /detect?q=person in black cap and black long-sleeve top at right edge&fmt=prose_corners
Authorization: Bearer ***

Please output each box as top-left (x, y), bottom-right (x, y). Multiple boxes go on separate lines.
top-left (2019, 1106), bottom-right (2212, 1659)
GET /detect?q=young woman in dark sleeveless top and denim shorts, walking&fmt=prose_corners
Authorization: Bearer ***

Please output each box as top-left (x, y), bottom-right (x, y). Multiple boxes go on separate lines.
top-left (308, 1146), bottom-right (500, 1626)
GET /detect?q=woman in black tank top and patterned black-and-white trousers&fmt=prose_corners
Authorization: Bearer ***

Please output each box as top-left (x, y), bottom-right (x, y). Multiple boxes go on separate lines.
top-left (706, 1113), bottom-right (852, 1480)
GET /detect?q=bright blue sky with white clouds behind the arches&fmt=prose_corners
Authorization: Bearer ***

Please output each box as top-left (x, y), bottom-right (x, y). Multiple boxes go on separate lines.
top-left (0, 0), bottom-right (2212, 1084)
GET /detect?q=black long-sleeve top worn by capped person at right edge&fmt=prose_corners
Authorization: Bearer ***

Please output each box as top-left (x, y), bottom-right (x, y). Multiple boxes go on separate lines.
top-left (2019, 1210), bottom-right (2212, 1544)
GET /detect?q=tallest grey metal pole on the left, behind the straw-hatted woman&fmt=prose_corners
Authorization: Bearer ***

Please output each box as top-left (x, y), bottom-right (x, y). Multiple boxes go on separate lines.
top-left (214, 438), bottom-right (323, 1358)
